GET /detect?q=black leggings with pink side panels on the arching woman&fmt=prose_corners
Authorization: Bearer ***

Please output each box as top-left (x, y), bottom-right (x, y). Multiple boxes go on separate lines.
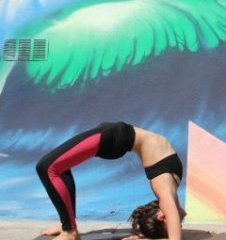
top-left (36, 122), bottom-right (135, 230)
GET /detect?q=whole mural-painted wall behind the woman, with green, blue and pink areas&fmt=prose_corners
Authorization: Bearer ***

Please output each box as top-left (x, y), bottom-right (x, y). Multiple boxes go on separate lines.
top-left (0, 0), bottom-right (226, 223)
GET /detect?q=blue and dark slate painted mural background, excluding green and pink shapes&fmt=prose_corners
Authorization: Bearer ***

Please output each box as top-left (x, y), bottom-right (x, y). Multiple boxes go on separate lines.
top-left (0, 0), bottom-right (226, 220)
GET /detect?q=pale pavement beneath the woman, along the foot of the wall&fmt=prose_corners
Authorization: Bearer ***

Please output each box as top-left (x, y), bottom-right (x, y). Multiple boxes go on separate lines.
top-left (0, 220), bottom-right (226, 240)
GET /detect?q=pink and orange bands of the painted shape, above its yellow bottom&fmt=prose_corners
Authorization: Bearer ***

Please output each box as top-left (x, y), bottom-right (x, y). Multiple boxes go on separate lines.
top-left (186, 122), bottom-right (226, 216)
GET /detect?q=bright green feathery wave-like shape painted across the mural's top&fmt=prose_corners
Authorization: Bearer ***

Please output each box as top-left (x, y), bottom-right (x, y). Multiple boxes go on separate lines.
top-left (19, 0), bottom-right (226, 89)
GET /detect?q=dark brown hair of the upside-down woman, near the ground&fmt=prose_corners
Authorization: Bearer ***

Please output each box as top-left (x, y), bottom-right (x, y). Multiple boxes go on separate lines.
top-left (129, 201), bottom-right (168, 239)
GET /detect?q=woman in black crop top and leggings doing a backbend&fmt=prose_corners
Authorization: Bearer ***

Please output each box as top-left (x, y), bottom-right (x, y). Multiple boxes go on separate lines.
top-left (36, 122), bottom-right (185, 240)
